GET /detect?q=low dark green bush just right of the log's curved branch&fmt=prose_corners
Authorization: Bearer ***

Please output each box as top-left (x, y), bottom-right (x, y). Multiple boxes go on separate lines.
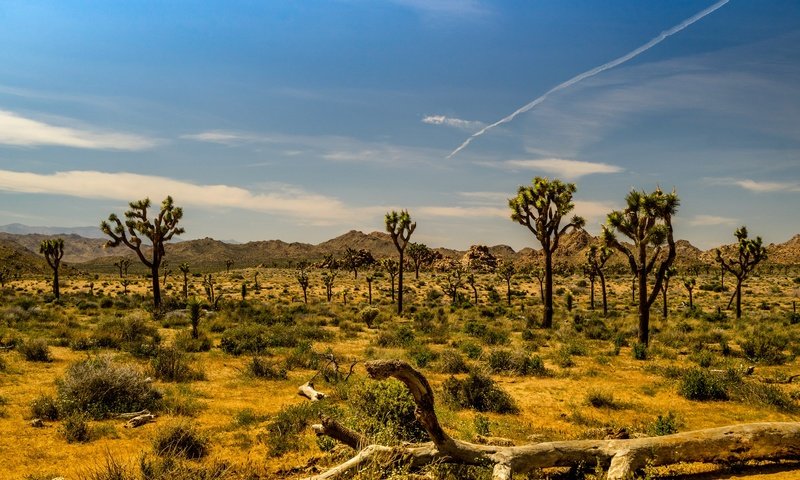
top-left (442, 371), bottom-right (519, 413)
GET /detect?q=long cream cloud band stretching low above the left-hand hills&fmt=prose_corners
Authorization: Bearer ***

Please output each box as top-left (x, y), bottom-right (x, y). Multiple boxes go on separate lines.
top-left (0, 170), bottom-right (358, 225)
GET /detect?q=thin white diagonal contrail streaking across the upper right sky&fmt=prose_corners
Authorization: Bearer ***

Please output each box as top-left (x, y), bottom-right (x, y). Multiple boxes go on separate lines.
top-left (447, 0), bottom-right (730, 158)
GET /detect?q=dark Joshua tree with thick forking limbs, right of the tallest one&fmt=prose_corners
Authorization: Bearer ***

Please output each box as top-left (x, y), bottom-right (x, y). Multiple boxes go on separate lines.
top-left (602, 188), bottom-right (680, 345)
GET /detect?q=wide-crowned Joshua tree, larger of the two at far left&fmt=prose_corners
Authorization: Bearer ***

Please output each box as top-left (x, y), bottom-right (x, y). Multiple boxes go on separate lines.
top-left (100, 196), bottom-right (184, 309)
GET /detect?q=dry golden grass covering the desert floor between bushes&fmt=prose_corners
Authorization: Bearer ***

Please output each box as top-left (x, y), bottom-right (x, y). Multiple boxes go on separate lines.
top-left (0, 269), bottom-right (800, 480)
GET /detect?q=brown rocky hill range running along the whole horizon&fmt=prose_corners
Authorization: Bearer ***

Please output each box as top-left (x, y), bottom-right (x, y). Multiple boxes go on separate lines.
top-left (0, 229), bottom-right (800, 272)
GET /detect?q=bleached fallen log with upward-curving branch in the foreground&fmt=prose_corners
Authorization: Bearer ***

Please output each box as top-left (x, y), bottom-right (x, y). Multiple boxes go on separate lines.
top-left (309, 360), bottom-right (800, 480)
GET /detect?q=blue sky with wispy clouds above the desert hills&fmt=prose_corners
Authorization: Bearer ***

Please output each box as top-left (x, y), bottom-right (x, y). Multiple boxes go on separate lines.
top-left (0, 0), bottom-right (800, 249)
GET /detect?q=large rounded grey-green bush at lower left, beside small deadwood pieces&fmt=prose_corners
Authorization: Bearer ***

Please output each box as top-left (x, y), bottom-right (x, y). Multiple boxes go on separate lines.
top-left (56, 356), bottom-right (161, 418)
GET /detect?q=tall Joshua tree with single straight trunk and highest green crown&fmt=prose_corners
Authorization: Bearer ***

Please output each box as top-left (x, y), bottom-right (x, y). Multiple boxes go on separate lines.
top-left (508, 177), bottom-right (586, 328)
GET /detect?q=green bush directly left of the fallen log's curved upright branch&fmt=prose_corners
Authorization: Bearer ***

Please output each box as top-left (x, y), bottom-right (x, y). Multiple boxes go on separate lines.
top-left (348, 379), bottom-right (428, 444)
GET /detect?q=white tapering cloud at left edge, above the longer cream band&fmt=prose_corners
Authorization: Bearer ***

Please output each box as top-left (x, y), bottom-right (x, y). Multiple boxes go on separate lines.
top-left (0, 110), bottom-right (157, 150)
